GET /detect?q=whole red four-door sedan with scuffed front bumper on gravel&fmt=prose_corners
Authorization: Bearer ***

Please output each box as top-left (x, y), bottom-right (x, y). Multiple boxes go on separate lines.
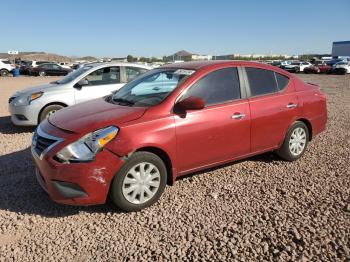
top-left (32, 61), bottom-right (327, 211)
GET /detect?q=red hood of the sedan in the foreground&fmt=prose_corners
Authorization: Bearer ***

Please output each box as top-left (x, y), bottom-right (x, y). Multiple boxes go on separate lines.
top-left (48, 98), bottom-right (146, 133)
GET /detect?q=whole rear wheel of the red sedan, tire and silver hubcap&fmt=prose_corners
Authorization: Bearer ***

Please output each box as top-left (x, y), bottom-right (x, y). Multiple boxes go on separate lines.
top-left (276, 121), bottom-right (310, 161)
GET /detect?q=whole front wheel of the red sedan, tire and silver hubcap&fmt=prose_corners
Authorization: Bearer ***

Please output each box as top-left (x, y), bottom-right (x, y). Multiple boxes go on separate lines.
top-left (110, 152), bottom-right (167, 211)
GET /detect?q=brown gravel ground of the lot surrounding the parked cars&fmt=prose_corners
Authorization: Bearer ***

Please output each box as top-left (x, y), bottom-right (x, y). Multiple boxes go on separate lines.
top-left (0, 75), bottom-right (350, 261)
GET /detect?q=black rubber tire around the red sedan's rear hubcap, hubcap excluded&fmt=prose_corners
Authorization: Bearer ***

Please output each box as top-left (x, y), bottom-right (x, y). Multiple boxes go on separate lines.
top-left (276, 121), bottom-right (310, 161)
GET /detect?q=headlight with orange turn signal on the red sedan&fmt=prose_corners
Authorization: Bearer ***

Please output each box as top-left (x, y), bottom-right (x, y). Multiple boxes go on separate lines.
top-left (56, 126), bottom-right (119, 163)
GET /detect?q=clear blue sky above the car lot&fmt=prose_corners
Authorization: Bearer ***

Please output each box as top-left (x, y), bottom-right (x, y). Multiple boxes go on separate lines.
top-left (0, 0), bottom-right (350, 57)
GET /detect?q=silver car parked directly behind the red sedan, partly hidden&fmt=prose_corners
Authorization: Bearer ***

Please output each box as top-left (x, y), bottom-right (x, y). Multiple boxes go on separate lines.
top-left (9, 63), bottom-right (152, 126)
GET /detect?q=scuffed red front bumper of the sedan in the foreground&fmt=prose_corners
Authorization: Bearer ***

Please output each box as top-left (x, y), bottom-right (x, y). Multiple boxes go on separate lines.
top-left (32, 134), bottom-right (124, 205)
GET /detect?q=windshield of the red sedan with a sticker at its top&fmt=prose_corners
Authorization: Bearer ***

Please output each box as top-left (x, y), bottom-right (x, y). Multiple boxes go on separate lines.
top-left (110, 69), bottom-right (195, 107)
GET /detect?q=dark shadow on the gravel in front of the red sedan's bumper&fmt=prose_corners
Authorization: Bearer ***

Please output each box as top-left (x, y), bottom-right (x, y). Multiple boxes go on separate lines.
top-left (0, 148), bottom-right (122, 217)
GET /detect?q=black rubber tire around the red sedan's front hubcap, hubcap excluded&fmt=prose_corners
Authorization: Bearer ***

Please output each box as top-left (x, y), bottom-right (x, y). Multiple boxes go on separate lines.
top-left (110, 151), bottom-right (167, 212)
